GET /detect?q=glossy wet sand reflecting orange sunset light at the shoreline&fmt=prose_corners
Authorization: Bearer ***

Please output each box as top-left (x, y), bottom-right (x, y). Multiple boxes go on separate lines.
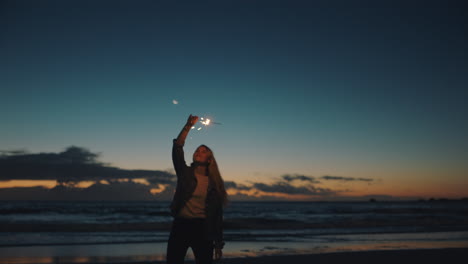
top-left (0, 232), bottom-right (468, 264)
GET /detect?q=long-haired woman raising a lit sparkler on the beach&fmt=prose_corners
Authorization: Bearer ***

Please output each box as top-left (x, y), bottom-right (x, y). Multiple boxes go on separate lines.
top-left (166, 115), bottom-right (227, 264)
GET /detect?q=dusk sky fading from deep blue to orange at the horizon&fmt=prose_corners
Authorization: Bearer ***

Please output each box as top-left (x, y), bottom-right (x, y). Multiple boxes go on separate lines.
top-left (0, 0), bottom-right (468, 199)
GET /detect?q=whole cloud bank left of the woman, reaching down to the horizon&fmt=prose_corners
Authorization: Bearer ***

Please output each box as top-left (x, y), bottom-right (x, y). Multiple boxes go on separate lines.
top-left (0, 146), bottom-right (180, 200)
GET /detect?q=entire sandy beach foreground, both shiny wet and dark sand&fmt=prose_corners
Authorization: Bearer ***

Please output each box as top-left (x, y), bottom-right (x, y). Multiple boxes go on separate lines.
top-left (0, 232), bottom-right (468, 264)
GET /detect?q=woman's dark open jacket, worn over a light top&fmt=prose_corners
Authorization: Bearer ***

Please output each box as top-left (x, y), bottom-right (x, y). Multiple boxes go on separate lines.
top-left (171, 139), bottom-right (224, 248)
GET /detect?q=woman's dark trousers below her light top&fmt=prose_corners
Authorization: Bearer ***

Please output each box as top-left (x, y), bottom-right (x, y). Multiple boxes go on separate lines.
top-left (166, 218), bottom-right (213, 264)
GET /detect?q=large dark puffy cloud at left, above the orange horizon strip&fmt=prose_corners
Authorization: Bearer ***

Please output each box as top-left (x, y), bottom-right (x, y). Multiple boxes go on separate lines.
top-left (0, 146), bottom-right (175, 184)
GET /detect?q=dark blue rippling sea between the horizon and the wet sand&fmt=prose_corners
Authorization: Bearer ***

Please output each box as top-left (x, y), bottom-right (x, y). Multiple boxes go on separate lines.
top-left (0, 202), bottom-right (468, 232)
